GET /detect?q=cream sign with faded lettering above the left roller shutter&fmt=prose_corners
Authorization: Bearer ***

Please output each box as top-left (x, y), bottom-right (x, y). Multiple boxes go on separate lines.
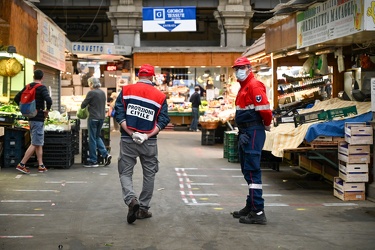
top-left (38, 13), bottom-right (65, 71)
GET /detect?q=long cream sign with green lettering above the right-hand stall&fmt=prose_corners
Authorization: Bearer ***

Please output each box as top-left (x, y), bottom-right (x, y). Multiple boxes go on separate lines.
top-left (297, 0), bottom-right (375, 49)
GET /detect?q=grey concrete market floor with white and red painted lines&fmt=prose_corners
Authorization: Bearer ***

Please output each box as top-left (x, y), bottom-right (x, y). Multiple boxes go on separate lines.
top-left (0, 131), bottom-right (375, 250)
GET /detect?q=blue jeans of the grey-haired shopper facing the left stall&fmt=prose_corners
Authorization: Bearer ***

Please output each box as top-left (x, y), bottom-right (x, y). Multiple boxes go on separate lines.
top-left (87, 119), bottom-right (108, 163)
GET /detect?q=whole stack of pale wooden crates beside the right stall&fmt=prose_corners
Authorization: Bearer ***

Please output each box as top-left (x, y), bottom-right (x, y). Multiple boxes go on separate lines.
top-left (334, 122), bottom-right (373, 200)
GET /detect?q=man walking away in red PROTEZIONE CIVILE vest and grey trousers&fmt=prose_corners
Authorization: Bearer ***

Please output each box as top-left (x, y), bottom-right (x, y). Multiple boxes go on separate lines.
top-left (115, 64), bottom-right (170, 224)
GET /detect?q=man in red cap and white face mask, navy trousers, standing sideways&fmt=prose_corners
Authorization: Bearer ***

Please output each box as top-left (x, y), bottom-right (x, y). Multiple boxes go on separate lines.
top-left (232, 57), bottom-right (272, 224)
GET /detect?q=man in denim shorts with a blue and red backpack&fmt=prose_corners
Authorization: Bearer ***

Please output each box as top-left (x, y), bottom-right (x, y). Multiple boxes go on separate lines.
top-left (14, 69), bottom-right (52, 174)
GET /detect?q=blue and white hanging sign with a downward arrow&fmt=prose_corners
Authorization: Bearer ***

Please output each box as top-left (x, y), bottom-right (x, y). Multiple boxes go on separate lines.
top-left (143, 6), bottom-right (197, 32)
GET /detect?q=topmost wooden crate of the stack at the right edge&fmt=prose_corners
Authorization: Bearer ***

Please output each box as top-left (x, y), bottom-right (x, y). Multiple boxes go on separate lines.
top-left (345, 122), bottom-right (373, 145)
